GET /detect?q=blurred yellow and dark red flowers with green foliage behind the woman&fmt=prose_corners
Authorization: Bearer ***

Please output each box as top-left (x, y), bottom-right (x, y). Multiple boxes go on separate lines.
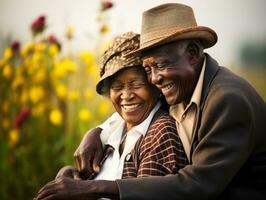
top-left (0, 1), bottom-right (112, 200)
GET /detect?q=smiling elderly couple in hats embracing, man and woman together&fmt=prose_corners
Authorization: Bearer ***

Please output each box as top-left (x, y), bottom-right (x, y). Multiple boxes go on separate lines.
top-left (35, 3), bottom-right (266, 200)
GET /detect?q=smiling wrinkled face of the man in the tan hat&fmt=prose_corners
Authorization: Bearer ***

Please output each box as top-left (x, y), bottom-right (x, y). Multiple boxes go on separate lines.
top-left (143, 40), bottom-right (203, 106)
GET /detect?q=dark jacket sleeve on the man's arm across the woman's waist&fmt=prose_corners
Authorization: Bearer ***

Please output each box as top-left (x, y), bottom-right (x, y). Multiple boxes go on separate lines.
top-left (116, 90), bottom-right (254, 200)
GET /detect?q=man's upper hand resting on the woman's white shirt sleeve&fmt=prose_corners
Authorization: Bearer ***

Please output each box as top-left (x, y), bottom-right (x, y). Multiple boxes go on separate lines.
top-left (74, 128), bottom-right (103, 178)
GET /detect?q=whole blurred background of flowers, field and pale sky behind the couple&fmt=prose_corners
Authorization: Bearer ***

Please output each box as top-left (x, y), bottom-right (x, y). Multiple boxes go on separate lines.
top-left (0, 0), bottom-right (266, 200)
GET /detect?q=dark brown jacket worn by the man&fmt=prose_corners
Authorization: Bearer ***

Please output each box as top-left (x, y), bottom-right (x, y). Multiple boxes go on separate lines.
top-left (117, 54), bottom-right (266, 200)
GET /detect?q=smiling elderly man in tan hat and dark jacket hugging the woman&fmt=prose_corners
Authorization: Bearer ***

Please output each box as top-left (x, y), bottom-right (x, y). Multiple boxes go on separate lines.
top-left (35, 4), bottom-right (266, 200)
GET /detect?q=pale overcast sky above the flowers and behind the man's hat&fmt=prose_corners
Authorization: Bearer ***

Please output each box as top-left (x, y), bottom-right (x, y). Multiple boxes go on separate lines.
top-left (0, 0), bottom-right (266, 65)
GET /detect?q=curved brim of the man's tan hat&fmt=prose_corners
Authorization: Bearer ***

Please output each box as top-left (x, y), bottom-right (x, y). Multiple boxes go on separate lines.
top-left (126, 26), bottom-right (218, 57)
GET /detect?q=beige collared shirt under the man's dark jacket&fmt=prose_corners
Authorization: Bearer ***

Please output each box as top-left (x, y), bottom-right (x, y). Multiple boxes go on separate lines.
top-left (170, 56), bottom-right (206, 160)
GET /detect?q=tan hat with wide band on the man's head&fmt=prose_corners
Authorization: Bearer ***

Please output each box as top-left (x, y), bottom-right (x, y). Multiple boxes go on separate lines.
top-left (129, 3), bottom-right (217, 55)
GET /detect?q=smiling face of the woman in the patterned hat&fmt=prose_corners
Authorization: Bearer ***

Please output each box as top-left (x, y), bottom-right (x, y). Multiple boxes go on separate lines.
top-left (110, 66), bottom-right (159, 129)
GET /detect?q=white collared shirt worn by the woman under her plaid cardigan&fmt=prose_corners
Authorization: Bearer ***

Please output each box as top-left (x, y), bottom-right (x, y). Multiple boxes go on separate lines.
top-left (95, 102), bottom-right (161, 180)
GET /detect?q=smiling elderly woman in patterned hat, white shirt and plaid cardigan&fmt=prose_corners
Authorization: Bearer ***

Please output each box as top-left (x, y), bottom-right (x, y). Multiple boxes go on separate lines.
top-left (34, 32), bottom-right (187, 199)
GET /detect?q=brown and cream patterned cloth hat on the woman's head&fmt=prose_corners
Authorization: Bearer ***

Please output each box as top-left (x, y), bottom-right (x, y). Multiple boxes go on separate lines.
top-left (96, 32), bottom-right (142, 94)
